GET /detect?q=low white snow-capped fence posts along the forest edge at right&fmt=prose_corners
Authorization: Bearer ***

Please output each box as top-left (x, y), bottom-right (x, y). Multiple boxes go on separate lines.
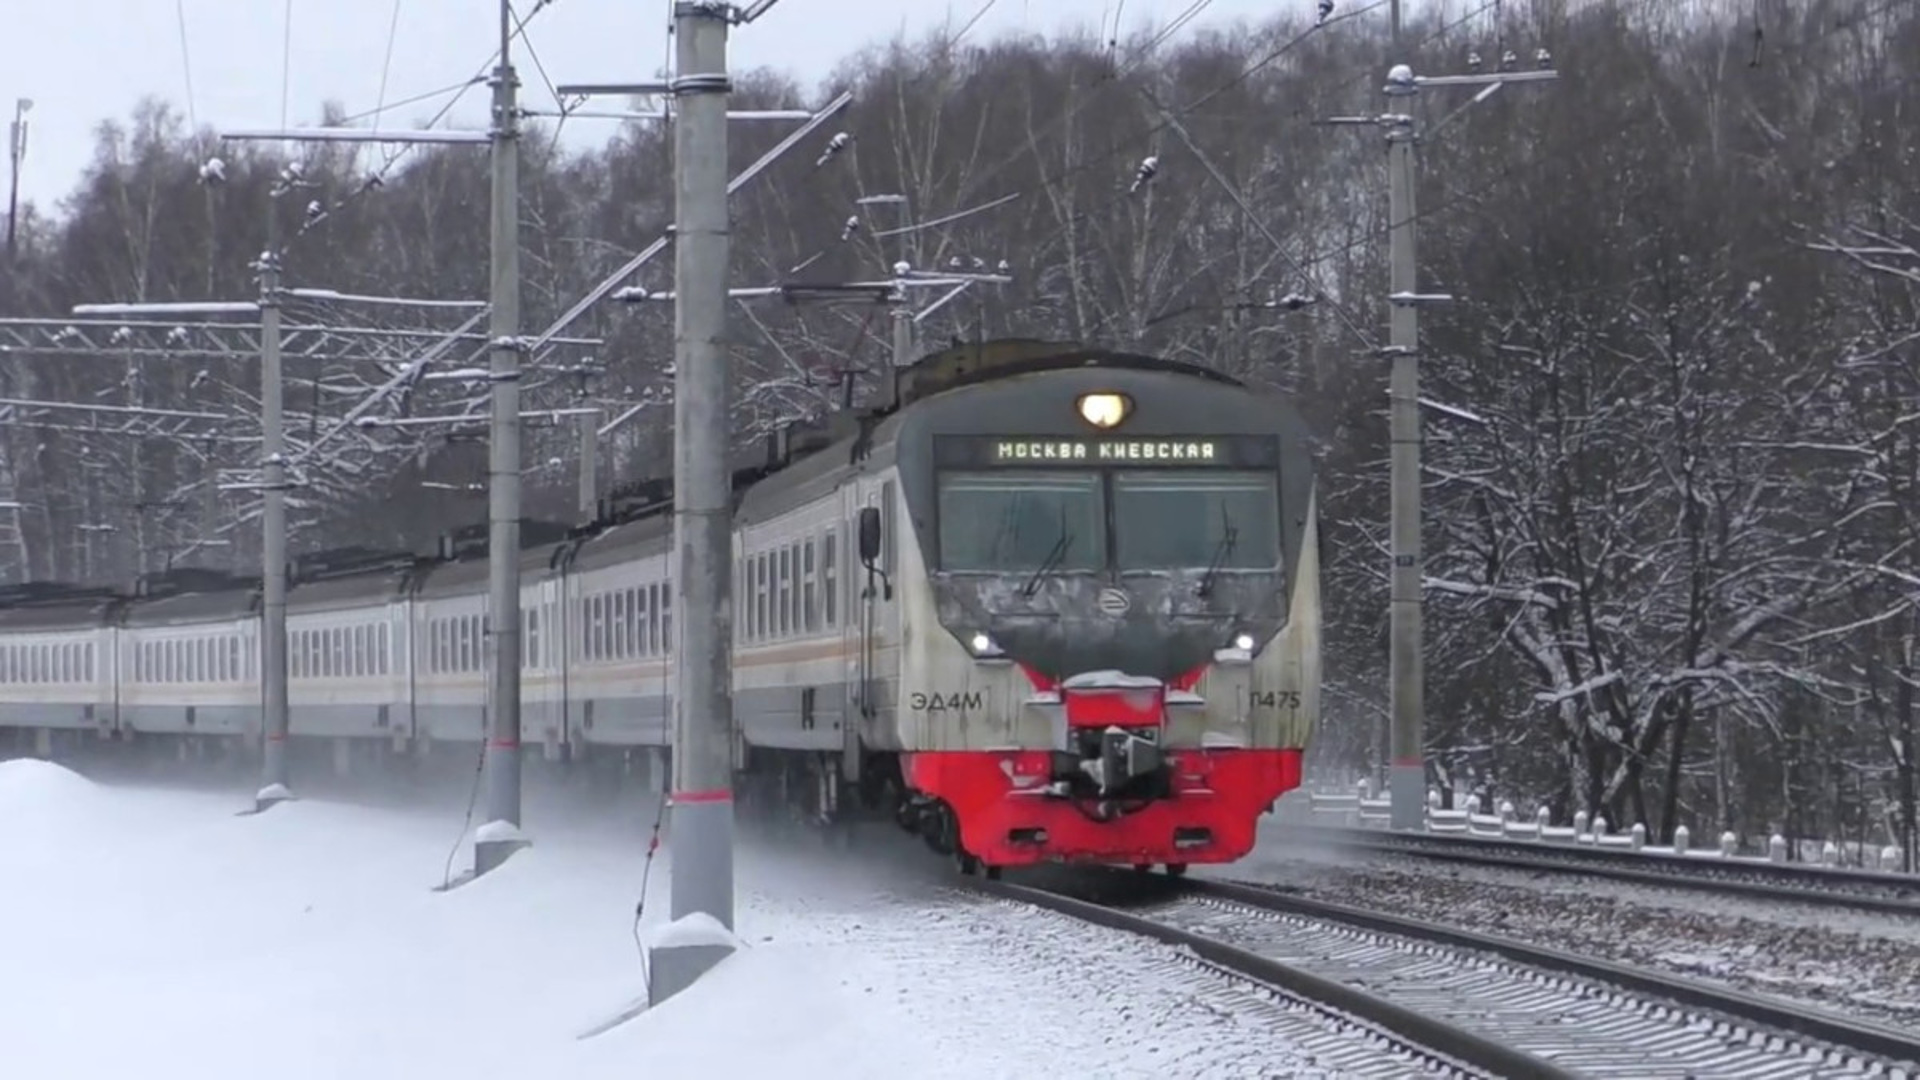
top-left (1277, 780), bottom-right (1901, 872)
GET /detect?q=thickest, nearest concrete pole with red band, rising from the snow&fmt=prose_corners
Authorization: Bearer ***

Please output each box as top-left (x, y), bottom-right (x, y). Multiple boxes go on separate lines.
top-left (649, 0), bottom-right (733, 1001)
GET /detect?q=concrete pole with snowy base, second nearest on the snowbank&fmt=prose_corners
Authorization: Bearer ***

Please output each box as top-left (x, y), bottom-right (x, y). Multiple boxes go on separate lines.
top-left (474, 0), bottom-right (526, 874)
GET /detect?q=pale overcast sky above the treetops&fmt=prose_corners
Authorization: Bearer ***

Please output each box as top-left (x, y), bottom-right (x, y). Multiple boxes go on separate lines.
top-left (0, 0), bottom-right (1359, 209)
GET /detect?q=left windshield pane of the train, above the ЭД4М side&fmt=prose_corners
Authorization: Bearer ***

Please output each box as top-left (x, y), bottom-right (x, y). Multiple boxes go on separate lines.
top-left (939, 471), bottom-right (1106, 571)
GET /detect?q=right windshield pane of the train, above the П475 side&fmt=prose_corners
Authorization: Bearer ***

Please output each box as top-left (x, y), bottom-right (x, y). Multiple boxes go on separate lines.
top-left (1114, 469), bottom-right (1281, 571)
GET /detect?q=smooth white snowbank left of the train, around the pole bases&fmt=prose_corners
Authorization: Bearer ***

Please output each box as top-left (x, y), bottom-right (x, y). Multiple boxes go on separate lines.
top-left (0, 761), bottom-right (1351, 1080)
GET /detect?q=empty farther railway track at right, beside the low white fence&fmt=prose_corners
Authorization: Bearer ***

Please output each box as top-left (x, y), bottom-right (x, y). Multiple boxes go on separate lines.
top-left (1292, 824), bottom-right (1920, 917)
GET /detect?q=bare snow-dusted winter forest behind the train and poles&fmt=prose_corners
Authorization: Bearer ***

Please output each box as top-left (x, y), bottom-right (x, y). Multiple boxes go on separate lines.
top-left (0, 0), bottom-right (1920, 867)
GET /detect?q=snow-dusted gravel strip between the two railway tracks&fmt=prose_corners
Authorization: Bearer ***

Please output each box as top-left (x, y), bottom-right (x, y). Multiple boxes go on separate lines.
top-left (1194, 807), bottom-right (1920, 1026)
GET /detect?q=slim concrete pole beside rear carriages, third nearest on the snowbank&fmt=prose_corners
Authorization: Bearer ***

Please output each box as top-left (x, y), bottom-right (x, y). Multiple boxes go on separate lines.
top-left (253, 197), bottom-right (292, 809)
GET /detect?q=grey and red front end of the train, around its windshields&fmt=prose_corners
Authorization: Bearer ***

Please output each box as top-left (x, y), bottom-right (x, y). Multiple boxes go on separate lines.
top-left (879, 361), bottom-right (1321, 871)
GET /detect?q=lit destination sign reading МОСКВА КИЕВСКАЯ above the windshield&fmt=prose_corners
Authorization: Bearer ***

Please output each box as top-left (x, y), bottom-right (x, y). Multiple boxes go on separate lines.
top-left (933, 434), bottom-right (1279, 469)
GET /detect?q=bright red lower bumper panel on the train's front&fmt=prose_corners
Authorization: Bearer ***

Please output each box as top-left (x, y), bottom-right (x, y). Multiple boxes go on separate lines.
top-left (902, 749), bottom-right (1300, 867)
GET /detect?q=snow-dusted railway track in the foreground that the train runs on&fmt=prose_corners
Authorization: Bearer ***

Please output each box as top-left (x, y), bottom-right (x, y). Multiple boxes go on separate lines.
top-left (981, 874), bottom-right (1920, 1080)
